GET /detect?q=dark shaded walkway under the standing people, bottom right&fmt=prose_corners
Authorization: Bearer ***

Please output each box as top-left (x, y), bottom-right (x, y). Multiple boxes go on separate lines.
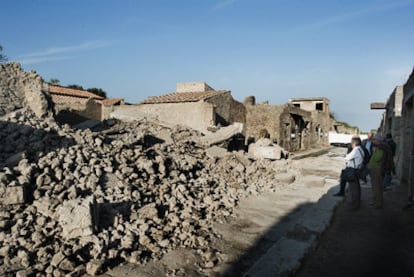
top-left (296, 180), bottom-right (414, 277)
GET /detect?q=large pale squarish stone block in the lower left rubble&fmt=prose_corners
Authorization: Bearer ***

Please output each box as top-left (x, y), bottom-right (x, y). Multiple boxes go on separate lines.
top-left (56, 196), bottom-right (99, 239)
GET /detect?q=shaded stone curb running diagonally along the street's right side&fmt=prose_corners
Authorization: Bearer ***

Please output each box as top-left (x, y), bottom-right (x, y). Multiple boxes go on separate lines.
top-left (244, 186), bottom-right (343, 277)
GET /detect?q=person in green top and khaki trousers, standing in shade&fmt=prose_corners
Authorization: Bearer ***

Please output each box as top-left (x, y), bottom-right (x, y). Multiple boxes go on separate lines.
top-left (368, 134), bottom-right (385, 209)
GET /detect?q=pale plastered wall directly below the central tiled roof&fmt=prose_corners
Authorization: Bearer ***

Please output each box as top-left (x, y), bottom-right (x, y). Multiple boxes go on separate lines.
top-left (111, 102), bottom-right (215, 132)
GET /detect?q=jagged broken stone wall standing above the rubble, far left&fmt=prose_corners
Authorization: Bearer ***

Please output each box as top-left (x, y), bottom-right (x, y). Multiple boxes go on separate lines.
top-left (0, 63), bottom-right (49, 117)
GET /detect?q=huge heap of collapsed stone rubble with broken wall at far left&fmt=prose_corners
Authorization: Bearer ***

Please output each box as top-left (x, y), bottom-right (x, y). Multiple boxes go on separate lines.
top-left (0, 64), bottom-right (294, 276)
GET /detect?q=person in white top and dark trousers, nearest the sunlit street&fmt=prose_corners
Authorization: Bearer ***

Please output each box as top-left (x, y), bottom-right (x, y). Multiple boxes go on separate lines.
top-left (334, 136), bottom-right (364, 199)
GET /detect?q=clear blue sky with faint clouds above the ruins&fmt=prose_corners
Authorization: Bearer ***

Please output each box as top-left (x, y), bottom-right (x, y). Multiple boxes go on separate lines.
top-left (0, 0), bottom-right (414, 130)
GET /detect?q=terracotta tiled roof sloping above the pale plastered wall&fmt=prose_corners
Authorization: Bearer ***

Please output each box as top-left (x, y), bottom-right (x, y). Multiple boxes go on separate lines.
top-left (141, 90), bottom-right (229, 104)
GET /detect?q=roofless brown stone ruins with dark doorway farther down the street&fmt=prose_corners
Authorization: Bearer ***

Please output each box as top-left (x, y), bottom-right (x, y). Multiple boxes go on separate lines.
top-left (245, 96), bottom-right (332, 151)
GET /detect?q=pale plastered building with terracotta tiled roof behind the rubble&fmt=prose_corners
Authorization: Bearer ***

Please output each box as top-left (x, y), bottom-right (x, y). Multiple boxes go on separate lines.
top-left (112, 82), bottom-right (246, 132)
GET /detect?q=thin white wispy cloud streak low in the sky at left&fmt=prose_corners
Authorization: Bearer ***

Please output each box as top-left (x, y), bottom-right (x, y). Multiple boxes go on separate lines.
top-left (19, 41), bottom-right (114, 64)
